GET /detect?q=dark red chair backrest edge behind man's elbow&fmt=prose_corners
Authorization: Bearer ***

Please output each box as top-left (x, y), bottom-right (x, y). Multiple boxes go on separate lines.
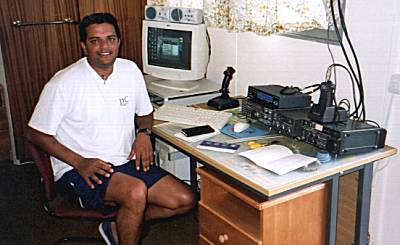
top-left (28, 143), bottom-right (55, 201)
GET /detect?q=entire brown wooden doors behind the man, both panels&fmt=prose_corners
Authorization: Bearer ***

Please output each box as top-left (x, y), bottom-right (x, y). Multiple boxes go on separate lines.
top-left (0, 0), bottom-right (146, 160)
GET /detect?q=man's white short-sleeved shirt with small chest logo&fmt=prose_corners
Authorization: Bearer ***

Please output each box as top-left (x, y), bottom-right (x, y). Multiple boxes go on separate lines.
top-left (28, 58), bottom-right (153, 180)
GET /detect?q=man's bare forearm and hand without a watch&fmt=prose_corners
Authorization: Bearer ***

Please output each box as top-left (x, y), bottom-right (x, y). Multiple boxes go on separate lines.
top-left (26, 127), bottom-right (113, 188)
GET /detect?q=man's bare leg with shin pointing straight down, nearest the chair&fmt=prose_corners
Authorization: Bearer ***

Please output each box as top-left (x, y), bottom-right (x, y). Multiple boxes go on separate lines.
top-left (105, 173), bottom-right (147, 245)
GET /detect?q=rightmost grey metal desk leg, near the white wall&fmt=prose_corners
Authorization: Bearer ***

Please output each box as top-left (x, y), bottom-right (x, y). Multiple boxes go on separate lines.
top-left (355, 163), bottom-right (373, 245)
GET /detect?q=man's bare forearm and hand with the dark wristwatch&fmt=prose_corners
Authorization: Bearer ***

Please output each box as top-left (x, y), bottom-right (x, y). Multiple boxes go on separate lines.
top-left (128, 113), bottom-right (153, 171)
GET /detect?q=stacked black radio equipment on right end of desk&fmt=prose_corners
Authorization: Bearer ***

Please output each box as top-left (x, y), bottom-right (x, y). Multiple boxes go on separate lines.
top-left (242, 84), bottom-right (386, 155)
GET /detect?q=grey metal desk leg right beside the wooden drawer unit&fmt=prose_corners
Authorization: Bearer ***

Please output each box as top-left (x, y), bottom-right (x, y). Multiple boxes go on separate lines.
top-left (327, 175), bottom-right (339, 245)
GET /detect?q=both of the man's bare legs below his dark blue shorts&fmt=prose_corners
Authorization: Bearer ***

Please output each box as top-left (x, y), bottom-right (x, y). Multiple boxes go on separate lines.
top-left (105, 173), bottom-right (196, 245)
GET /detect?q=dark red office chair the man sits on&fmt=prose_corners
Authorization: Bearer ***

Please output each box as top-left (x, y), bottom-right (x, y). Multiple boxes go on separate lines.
top-left (28, 143), bottom-right (117, 244)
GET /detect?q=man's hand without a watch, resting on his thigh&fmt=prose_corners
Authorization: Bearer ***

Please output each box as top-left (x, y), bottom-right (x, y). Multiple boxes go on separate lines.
top-left (76, 158), bottom-right (114, 189)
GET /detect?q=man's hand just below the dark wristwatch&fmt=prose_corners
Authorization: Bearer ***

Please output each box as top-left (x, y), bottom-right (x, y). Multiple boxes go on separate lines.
top-left (128, 133), bottom-right (153, 172)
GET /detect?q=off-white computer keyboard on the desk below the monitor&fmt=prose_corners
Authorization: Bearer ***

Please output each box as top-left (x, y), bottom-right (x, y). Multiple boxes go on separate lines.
top-left (154, 103), bottom-right (232, 129)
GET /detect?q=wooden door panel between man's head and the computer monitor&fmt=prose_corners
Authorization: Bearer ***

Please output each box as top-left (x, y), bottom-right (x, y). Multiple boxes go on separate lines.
top-left (79, 0), bottom-right (146, 68)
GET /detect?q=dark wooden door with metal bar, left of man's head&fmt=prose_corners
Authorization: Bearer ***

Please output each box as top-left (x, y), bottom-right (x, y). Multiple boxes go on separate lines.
top-left (0, 0), bottom-right (81, 160)
